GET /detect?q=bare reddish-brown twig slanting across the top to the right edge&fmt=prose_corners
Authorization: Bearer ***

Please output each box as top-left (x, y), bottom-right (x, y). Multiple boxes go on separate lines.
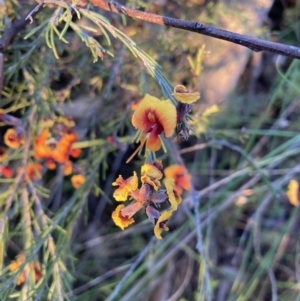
top-left (90, 0), bottom-right (300, 59)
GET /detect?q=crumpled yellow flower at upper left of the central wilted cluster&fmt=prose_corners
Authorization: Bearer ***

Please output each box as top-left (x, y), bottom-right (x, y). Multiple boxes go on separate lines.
top-left (112, 171), bottom-right (138, 202)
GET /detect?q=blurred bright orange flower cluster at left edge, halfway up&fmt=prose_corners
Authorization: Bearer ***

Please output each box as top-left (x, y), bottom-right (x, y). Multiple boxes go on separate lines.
top-left (0, 111), bottom-right (85, 189)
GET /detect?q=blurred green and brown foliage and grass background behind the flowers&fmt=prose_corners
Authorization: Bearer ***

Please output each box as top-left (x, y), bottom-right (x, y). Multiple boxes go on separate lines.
top-left (0, 0), bottom-right (300, 301)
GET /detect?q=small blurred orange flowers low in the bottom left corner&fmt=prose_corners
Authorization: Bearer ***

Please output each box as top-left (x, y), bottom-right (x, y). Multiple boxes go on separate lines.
top-left (8, 253), bottom-right (43, 285)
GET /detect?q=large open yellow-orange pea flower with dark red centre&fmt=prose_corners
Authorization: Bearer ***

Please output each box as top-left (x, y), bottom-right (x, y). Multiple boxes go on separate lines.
top-left (132, 94), bottom-right (177, 152)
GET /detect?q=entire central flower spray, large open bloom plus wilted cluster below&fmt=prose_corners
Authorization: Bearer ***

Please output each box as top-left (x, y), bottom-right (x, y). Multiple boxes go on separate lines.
top-left (112, 85), bottom-right (200, 239)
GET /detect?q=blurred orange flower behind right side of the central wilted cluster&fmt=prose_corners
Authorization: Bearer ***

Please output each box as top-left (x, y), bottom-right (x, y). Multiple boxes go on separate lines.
top-left (164, 164), bottom-right (191, 195)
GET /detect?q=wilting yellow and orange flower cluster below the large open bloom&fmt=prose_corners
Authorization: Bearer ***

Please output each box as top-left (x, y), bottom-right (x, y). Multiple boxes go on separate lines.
top-left (112, 160), bottom-right (190, 239)
